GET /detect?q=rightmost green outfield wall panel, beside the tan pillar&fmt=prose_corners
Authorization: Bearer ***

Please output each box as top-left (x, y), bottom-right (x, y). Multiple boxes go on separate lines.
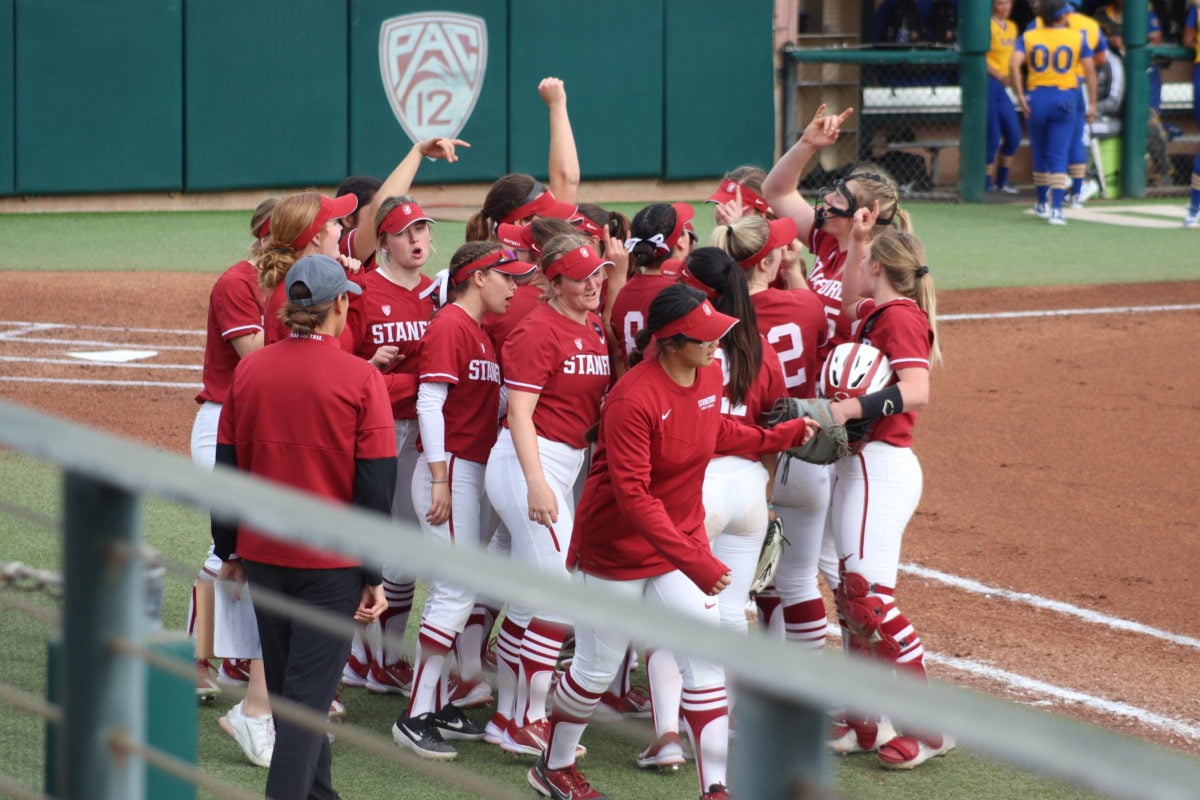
top-left (662, 0), bottom-right (775, 180)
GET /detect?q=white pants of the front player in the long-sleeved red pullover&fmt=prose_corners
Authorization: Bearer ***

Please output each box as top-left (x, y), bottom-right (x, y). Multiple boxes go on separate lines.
top-left (571, 570), bottom-right (725, 694)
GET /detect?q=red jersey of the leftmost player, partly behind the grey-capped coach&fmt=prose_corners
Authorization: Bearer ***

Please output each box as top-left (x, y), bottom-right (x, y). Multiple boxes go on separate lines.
top-left (196, 261), bottom-right (263, 403)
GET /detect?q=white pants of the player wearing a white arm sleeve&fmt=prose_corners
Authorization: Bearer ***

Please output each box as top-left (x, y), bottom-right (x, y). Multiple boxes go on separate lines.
top-left (413, 452), bottom-right (485, 633)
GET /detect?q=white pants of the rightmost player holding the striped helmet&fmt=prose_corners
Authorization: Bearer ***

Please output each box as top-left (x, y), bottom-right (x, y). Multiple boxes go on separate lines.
top-left (832, 441), bottom-right (923, 588)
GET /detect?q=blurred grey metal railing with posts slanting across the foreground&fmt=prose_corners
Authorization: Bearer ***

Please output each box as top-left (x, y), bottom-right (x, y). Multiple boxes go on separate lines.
top-left (7, 395), bottom-right (1200, 800)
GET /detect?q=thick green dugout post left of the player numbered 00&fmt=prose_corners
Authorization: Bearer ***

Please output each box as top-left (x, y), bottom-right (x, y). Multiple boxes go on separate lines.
top-left (959, 2), bottom-right (991, 203)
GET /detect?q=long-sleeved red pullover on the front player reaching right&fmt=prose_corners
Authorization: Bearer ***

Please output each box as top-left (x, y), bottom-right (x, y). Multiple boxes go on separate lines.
top-left (566, 359), bottom-right (803, 591)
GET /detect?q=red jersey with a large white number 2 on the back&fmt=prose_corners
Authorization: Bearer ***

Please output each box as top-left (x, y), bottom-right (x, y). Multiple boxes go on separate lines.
top-left (750, 289), bottom-right (829, 397)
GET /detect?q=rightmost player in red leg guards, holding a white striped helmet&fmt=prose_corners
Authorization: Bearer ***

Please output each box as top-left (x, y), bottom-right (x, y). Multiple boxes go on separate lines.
top-left (830, 209), bottom-right (954, 769)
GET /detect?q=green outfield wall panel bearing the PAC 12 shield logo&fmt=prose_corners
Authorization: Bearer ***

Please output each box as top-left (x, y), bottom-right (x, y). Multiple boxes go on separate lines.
top-left (349, 0), bottom-right (509, 184)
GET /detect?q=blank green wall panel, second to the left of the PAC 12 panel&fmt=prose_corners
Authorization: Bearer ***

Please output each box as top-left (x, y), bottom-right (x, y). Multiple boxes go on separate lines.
top-left (16, 0), bottom-right (184, 194)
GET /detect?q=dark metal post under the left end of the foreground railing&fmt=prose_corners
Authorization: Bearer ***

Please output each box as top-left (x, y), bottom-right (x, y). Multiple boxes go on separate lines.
top-left (58, 473), bottom-right (145, 800)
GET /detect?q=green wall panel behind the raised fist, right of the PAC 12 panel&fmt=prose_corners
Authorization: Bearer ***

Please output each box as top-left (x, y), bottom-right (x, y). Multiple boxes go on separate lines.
top-left (509, 0), bottom-right (662, 181)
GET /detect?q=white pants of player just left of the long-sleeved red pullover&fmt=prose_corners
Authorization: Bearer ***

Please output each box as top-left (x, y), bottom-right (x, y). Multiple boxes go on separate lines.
top-left (485, 428), bottom-right (587, 625)
